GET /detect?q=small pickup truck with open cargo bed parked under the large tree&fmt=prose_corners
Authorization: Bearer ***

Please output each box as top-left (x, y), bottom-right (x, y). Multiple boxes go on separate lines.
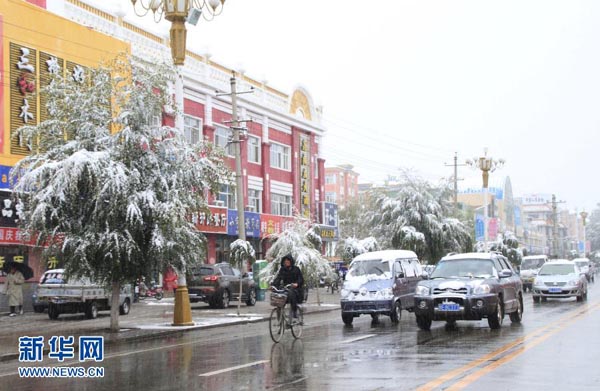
top-left (37, 269), bottom-right (133, 319)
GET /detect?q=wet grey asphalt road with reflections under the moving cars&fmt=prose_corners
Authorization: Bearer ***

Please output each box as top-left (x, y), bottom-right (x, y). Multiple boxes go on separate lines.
top-left (0, 284), bottom-right (600, 391)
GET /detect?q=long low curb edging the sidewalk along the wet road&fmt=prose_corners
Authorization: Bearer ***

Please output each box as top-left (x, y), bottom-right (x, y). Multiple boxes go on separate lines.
top-left (0, 305), bottom-right (340, 362)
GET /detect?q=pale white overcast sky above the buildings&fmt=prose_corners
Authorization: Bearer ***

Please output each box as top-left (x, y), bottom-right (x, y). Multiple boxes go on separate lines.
top-left (101, 0), bottom-right (600, 210)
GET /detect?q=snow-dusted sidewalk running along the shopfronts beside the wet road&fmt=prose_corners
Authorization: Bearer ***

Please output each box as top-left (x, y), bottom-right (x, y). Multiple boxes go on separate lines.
top-left (0, 289), bottom-right (340, 362)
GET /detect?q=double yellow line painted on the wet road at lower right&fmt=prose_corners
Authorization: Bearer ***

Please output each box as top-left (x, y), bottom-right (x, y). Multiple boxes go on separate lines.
top-left (416, 303), bottom-right (600, 391)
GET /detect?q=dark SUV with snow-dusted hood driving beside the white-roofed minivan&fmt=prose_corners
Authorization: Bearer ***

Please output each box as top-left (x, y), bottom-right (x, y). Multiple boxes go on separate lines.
top-left (414, 252), bottom-right (523, 330)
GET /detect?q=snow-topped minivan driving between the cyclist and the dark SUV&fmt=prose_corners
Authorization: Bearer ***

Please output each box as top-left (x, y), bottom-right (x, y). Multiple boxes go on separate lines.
top-left (340, 250), bottom-right (423, 325)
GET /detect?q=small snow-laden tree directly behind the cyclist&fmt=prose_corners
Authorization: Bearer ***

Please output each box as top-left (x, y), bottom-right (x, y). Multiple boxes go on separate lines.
top-left (261, 218), bottom-right (333, 301)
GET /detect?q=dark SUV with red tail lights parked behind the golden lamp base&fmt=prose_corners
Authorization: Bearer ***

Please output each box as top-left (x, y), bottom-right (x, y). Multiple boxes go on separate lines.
top-left (188, 262), bottom-right (256, 308)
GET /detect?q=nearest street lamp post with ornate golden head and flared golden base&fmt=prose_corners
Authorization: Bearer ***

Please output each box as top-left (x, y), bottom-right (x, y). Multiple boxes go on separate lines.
top-left (131, 0), bottom-right (225, 326)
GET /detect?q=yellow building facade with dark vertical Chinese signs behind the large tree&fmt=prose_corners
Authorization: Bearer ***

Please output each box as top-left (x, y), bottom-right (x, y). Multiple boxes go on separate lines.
top-left (0, 0), bottom-right (130, 294)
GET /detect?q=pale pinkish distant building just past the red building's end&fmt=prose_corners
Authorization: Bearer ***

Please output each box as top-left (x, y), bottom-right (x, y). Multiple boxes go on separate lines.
top-left (325, 164), bottom-right (359, 207)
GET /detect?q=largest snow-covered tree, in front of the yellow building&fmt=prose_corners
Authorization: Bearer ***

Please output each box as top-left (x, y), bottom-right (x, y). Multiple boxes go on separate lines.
top-left (11, 56), bottom-right (228, 330)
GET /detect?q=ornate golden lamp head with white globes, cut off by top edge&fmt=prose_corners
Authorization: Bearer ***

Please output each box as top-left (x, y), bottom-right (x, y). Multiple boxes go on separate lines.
top-left (131, 0), bottom-right (225, 65)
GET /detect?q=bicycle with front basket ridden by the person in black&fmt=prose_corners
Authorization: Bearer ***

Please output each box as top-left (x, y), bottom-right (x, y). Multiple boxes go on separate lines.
top-left (269, 285), bottom-right (304, 343)
